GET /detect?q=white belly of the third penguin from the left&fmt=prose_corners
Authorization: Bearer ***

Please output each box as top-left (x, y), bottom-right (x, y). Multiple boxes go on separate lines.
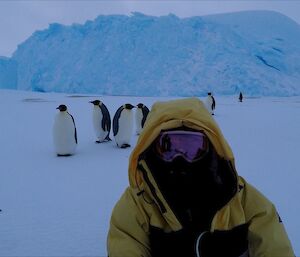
top-left (115, 109), bottom-right (133, 146)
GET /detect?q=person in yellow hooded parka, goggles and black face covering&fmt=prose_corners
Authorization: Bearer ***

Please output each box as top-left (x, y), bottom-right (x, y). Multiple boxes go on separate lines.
top-left (107, 98), bottom-right (295, 257)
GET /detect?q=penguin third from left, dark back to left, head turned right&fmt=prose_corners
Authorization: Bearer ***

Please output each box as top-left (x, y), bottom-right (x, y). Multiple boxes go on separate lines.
top-left (113, 104), bottom-right (134, 148)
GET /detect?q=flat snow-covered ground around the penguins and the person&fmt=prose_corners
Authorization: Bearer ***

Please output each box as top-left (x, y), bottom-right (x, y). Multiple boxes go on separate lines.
top-left (0, 90), bottom-right (300, 257)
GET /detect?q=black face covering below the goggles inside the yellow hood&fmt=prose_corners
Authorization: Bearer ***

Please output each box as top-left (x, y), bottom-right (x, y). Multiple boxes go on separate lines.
top-left (145, 140), bottom-right (236, 230)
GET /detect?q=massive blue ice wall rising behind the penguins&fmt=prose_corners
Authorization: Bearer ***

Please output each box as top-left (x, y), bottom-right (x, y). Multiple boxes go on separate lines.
top-left (0, 11), bottom-right (300, 96)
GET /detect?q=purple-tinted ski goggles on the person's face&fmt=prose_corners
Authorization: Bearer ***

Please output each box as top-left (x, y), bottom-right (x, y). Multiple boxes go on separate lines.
top-left (154, 130), bottom-right (209, 163)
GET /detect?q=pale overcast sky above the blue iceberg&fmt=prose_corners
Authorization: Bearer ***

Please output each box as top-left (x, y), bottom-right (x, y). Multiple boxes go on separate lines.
top-left (0, 0), bottom-right (300, 57)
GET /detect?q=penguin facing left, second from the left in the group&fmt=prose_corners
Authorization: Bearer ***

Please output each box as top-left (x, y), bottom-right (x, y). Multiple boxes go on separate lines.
top-left (90, 100), bottom-right (111, 143)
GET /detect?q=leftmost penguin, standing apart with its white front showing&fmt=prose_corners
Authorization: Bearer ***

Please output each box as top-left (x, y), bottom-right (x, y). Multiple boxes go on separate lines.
top-left (53, 104), bottom-right (77, 156)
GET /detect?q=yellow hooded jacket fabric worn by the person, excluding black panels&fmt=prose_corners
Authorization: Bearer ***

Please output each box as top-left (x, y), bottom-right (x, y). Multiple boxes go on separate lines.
top-left (107, 98), bottom-right (295, 257)
